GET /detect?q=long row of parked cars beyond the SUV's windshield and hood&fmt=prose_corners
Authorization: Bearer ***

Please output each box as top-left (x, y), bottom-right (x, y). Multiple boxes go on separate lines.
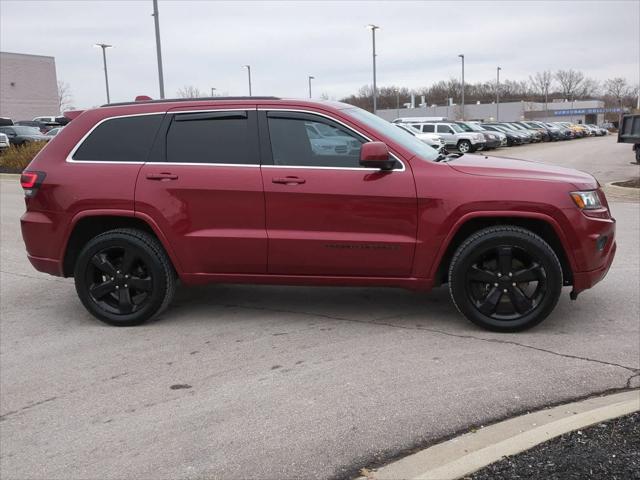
top-left (392, 117), bottom-right (608, 153)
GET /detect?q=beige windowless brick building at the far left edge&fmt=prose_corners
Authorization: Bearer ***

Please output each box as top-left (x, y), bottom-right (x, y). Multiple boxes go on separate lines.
top-left (0, 52), bottom-right (59, 120)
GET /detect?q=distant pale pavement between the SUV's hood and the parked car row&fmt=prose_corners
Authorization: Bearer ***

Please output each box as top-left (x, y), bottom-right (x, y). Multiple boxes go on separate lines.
top-left (488, 134), bottom-right (640, 185)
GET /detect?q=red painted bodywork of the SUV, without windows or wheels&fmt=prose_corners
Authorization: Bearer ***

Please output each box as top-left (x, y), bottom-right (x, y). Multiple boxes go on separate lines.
top-left (21, 99), bottom-right (615, 291)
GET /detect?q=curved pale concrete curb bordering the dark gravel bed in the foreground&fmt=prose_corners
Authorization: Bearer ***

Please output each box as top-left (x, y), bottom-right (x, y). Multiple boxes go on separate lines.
top-left (361, 390), bottom-right (640, 480)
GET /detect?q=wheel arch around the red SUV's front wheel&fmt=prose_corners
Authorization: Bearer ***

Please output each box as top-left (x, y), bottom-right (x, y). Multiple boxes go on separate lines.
top-left (430, 212), bottom-right (575, 285)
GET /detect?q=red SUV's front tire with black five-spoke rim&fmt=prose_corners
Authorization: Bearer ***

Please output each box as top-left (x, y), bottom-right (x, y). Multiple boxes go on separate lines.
top-left (449, 225), bottom-right (563, 332)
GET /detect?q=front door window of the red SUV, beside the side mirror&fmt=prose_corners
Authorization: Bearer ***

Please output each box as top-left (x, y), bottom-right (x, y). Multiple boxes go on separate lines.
top-left (269, 116), bottom-right (364, 168)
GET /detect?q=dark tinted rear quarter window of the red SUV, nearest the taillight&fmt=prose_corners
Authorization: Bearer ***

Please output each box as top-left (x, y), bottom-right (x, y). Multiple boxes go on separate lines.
top-left (73, 115), bottom-right (163, 162)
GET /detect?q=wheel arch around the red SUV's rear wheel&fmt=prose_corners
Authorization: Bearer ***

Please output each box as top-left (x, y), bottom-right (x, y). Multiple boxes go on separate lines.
top-left (62, 210), bottom-right (181, 277)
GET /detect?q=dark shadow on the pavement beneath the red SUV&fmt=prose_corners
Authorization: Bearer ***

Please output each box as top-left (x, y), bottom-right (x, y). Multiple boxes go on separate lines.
top-left (157, 285), bottom-right (567, 334)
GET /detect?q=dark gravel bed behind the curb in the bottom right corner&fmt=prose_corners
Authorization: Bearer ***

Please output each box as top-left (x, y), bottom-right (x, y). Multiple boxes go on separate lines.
top-left (465, 412), bottom-right (640, 480)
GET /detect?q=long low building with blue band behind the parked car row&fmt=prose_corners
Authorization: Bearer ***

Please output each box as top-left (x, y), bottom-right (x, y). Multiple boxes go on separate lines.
top-left (376, 100), bottom-right (620, 125)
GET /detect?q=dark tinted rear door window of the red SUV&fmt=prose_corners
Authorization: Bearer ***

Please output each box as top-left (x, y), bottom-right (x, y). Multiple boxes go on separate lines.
top-left (167, 112), bottom-right (252, 165)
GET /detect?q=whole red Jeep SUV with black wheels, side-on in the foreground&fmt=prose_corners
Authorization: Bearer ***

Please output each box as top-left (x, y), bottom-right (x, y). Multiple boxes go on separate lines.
top-left (21, 97), bottom-right (616, 331)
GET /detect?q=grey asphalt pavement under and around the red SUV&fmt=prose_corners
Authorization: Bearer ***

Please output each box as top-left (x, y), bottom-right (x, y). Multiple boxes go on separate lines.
top-left (0, 139), bottom-right (640, 480)
